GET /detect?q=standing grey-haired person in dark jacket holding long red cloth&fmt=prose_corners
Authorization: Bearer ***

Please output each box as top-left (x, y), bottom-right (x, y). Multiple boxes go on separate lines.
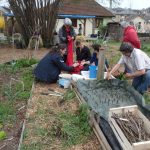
top-left (59, 18), bottom-right (76, 66)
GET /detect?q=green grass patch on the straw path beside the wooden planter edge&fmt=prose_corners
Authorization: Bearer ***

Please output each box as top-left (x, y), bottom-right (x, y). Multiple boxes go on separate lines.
top-left (52, 105), bottom-right (91, 146)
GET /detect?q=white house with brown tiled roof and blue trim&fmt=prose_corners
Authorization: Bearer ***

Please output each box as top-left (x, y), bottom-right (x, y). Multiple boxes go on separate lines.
top-left (56, 0), bottom-right (114, 36)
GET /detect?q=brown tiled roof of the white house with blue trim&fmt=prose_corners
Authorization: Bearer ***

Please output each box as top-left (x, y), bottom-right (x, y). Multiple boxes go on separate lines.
top-left (59, 0), bottom-right (114, 17)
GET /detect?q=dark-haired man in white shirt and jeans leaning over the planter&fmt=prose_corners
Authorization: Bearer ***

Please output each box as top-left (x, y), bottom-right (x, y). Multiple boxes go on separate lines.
top-left (107, 42), bottom-right (150, 95)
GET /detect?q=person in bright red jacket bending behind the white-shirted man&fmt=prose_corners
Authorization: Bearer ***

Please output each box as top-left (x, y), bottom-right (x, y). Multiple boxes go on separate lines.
top-left (120, 21), bottom-right (141, 49)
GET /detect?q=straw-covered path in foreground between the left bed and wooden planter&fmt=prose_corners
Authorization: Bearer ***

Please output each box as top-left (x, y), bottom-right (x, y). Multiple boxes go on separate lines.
top-left (22, 83), bottom-right (101, 150)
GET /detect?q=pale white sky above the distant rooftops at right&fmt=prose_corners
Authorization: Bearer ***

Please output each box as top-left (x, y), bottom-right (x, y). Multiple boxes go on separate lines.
top-left (98, 0), bottom-right (150, 9)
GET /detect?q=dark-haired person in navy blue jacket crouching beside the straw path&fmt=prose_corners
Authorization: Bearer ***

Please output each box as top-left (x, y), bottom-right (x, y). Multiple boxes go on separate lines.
top-left (34, 44), bottom-right (78, 83)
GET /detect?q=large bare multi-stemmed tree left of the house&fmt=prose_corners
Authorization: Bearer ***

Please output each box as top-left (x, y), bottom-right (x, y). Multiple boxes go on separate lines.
top-left (8, 0), bottom-right (62, 46)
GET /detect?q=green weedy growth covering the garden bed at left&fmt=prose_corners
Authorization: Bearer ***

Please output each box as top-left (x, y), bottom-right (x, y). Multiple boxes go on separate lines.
top-left (0, 59), bottom-right (36, 141)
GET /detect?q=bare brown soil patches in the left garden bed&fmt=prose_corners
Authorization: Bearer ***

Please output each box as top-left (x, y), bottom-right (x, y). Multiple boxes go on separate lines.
top-left (0, 67), bottom-right (27, 150)
